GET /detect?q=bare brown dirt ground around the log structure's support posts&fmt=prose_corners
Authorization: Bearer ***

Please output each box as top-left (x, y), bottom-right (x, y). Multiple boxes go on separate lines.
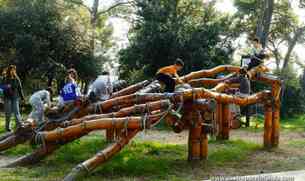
top-left (0, 129), bottom-right (305, 180)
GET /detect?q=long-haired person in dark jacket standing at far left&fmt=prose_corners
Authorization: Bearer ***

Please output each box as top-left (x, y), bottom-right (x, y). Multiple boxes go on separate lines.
top-left (2, 65), bottom-right (24, 131)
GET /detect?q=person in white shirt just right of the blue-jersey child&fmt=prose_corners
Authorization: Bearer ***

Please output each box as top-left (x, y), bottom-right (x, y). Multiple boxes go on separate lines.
top-left (87, 72), bottom-right (113, 102)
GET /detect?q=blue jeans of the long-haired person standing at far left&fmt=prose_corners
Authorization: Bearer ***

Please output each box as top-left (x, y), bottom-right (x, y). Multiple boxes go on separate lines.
top-left (4, 98), bottom-right (22, 131)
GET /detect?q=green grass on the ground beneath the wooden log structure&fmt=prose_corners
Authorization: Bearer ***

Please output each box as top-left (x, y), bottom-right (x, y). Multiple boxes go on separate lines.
top-left (0, 137), bottom-right (259, 181)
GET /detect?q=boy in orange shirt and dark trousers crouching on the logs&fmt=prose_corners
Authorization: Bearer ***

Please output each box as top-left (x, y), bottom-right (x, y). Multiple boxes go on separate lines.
top-left (156, 58), bottom-right (184, 92)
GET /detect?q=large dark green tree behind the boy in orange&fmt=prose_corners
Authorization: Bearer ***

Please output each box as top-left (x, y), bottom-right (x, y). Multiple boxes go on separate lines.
top-left (119, 0), bottom-right (234, 80)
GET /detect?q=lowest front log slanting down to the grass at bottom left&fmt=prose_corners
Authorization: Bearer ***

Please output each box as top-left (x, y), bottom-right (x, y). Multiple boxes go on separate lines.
top-left (64, 129), bottom-right (140, 181)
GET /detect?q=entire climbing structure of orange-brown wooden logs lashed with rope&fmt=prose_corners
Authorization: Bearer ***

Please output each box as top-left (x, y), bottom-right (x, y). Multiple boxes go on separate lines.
top-left (0, 65), bottom-right (281, 180)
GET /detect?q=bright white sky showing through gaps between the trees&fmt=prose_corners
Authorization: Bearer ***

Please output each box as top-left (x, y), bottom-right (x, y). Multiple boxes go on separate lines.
top-left (85, 0), bottom-right (305, 71)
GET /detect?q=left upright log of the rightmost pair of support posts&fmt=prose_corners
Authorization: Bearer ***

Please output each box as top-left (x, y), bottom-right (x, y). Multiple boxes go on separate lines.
top-left (264, 105), bottom-right (272, 148)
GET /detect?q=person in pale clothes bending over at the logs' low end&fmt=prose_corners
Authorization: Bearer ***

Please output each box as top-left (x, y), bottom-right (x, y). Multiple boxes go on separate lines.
top-left (29, 88), bottom-right (52, 125)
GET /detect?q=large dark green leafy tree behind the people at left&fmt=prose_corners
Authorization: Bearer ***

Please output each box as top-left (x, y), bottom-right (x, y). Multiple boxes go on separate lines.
top-left (0, 0), bottom-right (103, 90)
